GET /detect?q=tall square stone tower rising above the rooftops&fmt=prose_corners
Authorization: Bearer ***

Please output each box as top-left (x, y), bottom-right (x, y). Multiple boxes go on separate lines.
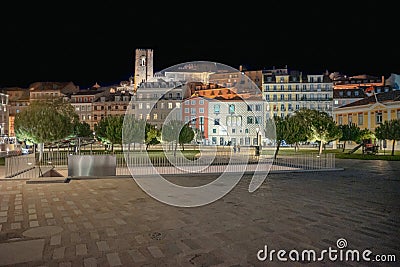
top-left (133, 49), bottom-right (153, 90)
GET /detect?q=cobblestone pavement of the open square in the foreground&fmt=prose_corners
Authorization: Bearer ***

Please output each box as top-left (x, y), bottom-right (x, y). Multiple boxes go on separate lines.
top-left (0, 160), bottom-right (400, 266)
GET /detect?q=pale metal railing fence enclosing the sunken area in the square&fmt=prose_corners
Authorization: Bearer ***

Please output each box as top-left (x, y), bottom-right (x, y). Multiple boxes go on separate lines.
top-left (5, 151), bottom-right (335, 178)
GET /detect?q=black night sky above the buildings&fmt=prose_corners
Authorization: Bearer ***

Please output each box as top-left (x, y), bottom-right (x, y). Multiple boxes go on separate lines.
top-left (0, 1), bottom-right (400, 88)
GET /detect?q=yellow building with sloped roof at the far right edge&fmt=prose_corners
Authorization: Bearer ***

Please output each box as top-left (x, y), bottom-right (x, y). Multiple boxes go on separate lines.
top-left (333, 90), bottom-right (400, 132)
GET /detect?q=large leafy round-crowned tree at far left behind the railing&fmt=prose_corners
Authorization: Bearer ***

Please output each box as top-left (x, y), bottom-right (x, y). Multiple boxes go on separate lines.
top-left (14, 98), bottom-right (79, 162)
